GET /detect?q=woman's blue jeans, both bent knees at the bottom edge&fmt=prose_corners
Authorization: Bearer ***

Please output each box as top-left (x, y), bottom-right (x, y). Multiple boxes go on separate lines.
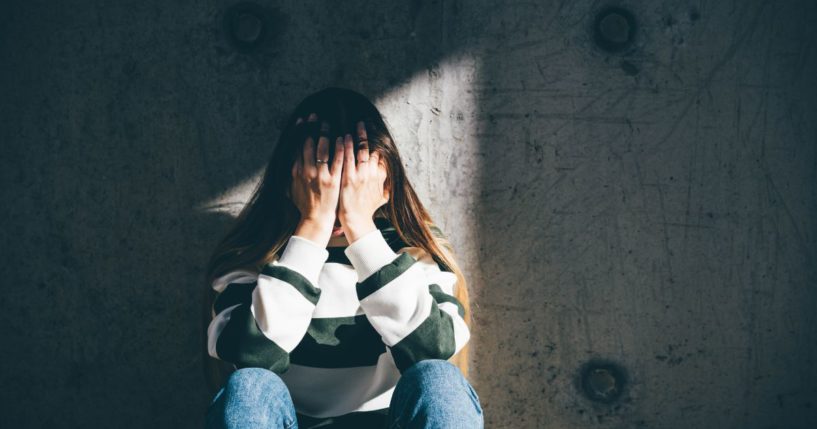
top-left (205, 359), bottom-right (483, 429)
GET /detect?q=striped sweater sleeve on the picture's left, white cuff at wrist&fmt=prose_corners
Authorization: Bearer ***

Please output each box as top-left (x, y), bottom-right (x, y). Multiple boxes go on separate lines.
top-left (207, 235), bottom-right (329, 374)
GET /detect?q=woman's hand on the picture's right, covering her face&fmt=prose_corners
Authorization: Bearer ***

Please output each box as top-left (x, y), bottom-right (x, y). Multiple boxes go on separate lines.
top-left (338, 121), bottom-right (389, 244)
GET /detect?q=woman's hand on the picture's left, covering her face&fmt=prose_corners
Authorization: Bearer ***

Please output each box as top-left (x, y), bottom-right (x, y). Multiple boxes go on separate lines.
top-left (289, 113), bottom-right (344, 246)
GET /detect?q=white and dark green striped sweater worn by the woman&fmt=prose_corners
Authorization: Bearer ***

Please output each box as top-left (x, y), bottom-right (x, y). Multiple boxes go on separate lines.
top-left (207, 218), bottom-right (470, 418)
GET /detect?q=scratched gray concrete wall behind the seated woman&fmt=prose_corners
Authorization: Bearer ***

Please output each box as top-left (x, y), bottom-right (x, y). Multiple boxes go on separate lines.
top-left (0, 0), bottom-right (817, 429)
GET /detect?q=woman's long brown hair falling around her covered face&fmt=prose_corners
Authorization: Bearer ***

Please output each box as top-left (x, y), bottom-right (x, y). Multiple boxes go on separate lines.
top-left (201, 87), bottom-right (471, 393)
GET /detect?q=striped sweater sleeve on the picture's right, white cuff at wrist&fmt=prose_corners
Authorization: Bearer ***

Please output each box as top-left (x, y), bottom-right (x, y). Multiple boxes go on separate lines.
top-left (344, 230), bottom-right (470, 373)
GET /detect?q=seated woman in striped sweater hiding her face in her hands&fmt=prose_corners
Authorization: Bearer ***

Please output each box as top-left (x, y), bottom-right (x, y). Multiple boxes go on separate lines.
top-left (205, 88), bottom-right (483, 429)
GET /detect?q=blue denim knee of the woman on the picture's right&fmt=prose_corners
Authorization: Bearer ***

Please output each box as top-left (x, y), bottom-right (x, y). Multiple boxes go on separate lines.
top-left (387, 359), bottom-right (484, 429)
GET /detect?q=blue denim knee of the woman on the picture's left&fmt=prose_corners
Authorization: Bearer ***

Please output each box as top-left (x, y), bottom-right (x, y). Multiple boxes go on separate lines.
top-left (205, 368), bottom-right (298, 429)
